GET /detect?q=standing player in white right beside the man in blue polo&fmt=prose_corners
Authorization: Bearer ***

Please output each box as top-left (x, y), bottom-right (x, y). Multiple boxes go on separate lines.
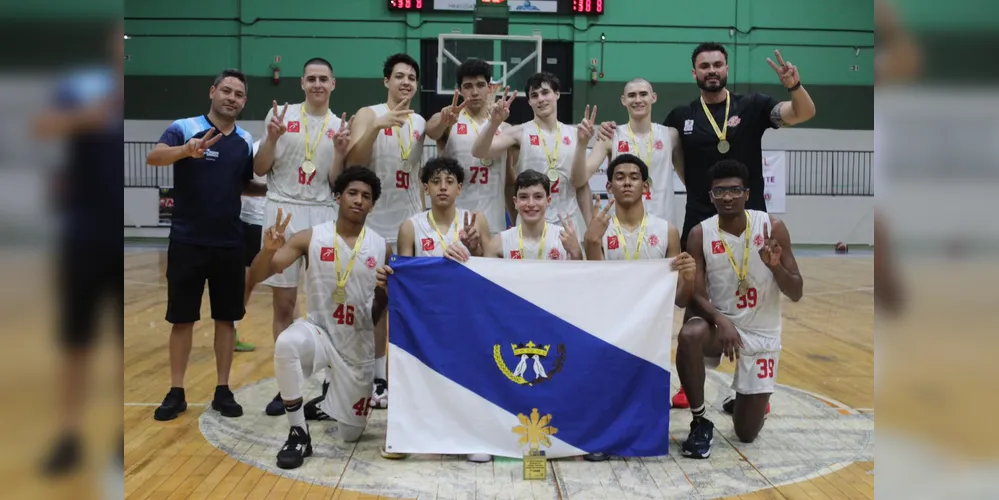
top-left (253, 58), bottom-right (350, 416)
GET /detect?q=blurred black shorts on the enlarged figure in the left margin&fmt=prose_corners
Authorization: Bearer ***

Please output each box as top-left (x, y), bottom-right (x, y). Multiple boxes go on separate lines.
top-left (57, 240), bottom-right (125, 349)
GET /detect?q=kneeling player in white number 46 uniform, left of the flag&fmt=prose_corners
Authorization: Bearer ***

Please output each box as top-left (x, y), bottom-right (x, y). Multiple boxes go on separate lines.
top-left (244, 167), bottom-right (391, 469)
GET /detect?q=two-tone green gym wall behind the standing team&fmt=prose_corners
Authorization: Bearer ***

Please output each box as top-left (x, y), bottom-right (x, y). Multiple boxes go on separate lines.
top-left (125, 0), bottom-right (874, 129)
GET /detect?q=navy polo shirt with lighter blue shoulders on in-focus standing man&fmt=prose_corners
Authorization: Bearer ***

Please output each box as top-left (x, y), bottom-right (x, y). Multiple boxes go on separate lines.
top-left (160, 115), bottom-right (253, 247)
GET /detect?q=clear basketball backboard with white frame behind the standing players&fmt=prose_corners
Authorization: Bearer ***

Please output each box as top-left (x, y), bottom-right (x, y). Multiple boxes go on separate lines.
top-left (437, 33), bottom-right (541, 96)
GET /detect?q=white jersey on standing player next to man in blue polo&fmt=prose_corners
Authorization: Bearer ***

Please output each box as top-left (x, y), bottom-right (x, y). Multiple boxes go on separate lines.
top-left (265, 103), bottom-right (340, 205)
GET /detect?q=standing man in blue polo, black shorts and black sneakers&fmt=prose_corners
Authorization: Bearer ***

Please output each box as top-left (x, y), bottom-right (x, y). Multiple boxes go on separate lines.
top-left (146, 69), bottom-right (265, 420)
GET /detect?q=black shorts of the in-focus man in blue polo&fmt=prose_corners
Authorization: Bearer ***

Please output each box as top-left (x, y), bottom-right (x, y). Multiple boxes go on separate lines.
top-left (166, 241), bottom-right (246, 324)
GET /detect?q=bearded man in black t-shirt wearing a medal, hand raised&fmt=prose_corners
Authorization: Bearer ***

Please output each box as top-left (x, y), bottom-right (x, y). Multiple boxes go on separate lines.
top-left (663, 43), bottom-right (815, 250)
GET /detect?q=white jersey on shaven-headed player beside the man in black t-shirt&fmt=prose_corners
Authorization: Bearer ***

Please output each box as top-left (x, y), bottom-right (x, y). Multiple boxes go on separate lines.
top-left (611, 123), bottom-right (675, 220)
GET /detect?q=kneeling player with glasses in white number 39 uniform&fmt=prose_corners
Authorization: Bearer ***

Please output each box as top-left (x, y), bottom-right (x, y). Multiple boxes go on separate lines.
top-left (676, 160), bottom-right (803, 458)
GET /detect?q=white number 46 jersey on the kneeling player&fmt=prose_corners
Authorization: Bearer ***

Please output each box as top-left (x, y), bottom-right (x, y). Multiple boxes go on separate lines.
top-left (306, 221), bottom-right (385, 363)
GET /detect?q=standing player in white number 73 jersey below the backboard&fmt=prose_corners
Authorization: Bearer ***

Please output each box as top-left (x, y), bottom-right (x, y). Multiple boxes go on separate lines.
top-left (427, 59), bottom-right (510, 233)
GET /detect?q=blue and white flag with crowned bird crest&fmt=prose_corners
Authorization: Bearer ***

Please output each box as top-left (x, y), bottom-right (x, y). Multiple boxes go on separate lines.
top-left (386, 256), bottom-right (677, 458)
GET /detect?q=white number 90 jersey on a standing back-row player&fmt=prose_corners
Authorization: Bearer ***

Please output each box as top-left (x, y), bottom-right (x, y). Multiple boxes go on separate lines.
top-left (367, 104), bottom-right (427, 241)
